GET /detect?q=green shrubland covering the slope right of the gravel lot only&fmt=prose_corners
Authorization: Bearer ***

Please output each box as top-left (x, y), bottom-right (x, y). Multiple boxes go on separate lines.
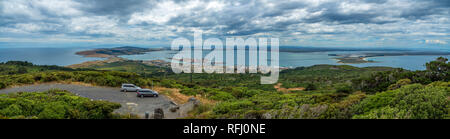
top-left (185, 58), bottom-right (450, 119)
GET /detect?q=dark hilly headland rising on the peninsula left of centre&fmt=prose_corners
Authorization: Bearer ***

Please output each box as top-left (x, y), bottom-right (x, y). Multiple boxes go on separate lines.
top-left (75, 46), bottom-right (166, 58)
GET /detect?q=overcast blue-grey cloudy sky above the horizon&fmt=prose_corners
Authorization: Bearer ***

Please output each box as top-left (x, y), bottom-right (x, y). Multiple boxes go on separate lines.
top-left (0, 0), bottom-right (450, 48)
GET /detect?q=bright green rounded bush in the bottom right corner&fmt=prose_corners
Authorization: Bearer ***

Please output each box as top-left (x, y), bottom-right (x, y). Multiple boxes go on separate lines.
top-left (353, 82), bottom-right (450, 119)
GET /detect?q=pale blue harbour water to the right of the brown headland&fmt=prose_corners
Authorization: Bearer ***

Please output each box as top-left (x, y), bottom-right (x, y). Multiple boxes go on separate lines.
top-left (120, 51), bottom-right (450, 70)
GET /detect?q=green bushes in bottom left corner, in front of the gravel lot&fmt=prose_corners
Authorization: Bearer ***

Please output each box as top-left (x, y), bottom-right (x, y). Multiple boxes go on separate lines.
top-left (0, 90), bottom-right (121, 119)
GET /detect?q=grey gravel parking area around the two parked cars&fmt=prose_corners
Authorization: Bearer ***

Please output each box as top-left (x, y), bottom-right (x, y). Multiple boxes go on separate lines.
top-left (0, 83), bottom-right (180, 119)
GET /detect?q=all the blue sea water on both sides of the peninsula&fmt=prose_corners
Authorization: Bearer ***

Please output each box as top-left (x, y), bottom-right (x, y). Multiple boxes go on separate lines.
top-left (0, 48), bottom-right (450, 70)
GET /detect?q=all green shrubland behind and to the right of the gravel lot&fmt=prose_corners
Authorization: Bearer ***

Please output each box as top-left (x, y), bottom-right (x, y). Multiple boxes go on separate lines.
top-left (0, 58), bottom-right (450, 119)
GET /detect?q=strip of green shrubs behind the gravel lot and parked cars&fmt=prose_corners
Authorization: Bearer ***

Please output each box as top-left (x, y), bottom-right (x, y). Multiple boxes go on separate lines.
top-left (0, 61), bottom-right (171, 89)
